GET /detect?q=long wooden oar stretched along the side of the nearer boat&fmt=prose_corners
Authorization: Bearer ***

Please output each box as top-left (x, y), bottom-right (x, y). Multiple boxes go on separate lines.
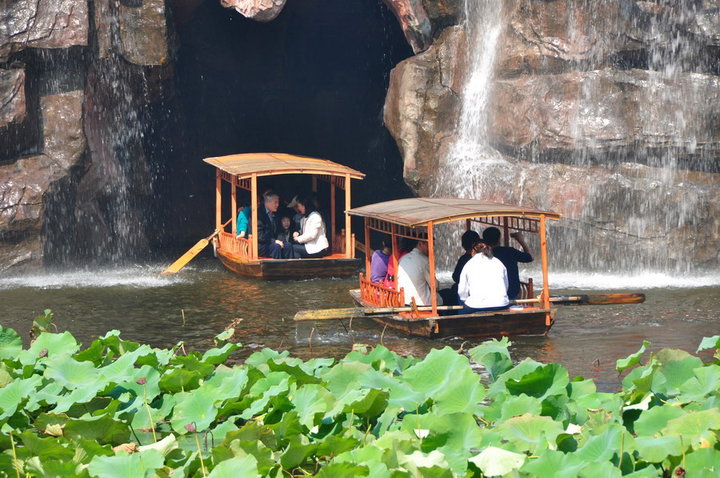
top-left (295, 293), bottom-right (645, 322)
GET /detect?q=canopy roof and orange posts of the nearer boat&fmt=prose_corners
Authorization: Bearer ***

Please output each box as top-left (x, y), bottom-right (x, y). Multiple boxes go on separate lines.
top-left (346, 197), bottom-right (561, 327)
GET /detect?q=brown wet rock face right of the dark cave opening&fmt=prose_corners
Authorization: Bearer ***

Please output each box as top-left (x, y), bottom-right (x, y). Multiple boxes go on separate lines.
top-left (385, 0), bottom-right (720, 268)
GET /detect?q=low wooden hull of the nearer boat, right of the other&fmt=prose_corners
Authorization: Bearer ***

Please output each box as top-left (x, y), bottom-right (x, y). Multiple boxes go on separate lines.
top-left (351, 291), bottom-right (555, 339)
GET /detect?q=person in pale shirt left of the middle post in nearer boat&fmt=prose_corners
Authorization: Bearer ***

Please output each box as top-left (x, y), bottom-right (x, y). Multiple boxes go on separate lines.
top-left (397, 241), bottom-right (443, 306)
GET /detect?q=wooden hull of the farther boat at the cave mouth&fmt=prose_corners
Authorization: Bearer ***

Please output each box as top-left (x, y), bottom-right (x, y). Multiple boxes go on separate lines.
top-left (217, 249), bottom-right (360, 280)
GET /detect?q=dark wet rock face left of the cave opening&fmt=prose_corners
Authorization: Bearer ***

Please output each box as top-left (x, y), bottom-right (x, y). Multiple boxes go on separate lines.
top-left (0, 0), bottom-right (172, 271)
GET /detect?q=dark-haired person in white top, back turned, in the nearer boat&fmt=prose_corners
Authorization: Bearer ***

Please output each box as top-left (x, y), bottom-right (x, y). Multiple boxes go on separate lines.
top-left (458, 241), bottom-right (510, 314)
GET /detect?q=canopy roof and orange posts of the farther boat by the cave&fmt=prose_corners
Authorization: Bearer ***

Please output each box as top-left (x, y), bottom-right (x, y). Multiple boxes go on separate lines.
top-left (203, 153), bottom-right (365, 260)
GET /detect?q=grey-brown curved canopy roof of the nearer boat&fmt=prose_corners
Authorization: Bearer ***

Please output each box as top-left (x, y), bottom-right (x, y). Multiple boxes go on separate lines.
top-left (347, 198), bottom-right (560, 227)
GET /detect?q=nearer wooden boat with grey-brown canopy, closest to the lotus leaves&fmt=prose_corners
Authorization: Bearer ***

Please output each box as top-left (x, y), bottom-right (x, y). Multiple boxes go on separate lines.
top-left (348, 198), bottom-right (560, 338)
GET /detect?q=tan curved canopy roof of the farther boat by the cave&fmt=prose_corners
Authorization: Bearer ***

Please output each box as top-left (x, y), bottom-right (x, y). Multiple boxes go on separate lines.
top-left (203, 153), bottom-right (365, 179)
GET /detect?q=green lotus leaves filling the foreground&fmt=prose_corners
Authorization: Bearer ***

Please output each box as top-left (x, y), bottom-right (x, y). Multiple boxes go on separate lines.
top-left (0, 311), bottom-right (720, 478)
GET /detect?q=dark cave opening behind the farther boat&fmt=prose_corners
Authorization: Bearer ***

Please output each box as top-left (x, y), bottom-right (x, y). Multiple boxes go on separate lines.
top-left (154, 0), bottom-right (412, 247)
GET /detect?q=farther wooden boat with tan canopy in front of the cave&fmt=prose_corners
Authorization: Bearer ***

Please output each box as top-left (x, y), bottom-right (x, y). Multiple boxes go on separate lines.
top-left (203, 153), bottom-right (365, 280)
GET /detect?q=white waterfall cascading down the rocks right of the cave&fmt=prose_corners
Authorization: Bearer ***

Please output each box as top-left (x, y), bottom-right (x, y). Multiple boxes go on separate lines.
top-left (433, 0), bottom-right (720, 274)
